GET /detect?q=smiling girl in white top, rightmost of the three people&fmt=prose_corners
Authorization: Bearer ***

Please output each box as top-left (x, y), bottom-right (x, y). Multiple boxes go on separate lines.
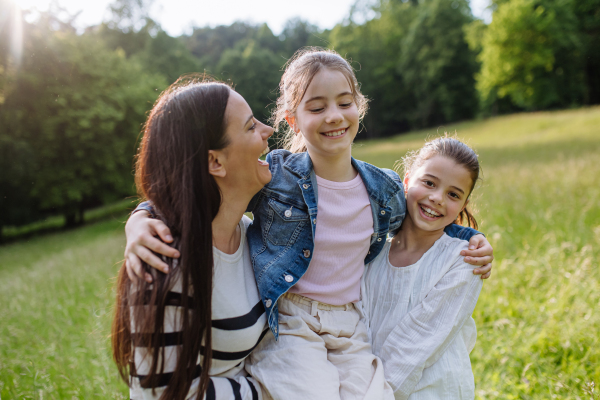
top-left (362, 137), bottom-right (481, 400)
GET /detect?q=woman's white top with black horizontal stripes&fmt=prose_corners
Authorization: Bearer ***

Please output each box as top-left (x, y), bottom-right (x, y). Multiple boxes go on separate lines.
top-left (130, 216), bottom-right (268, 400)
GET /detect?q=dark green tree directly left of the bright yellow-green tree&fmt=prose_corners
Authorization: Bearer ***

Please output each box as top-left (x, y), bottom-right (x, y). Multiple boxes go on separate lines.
top-left (398, 0), bottom-right (477, 128)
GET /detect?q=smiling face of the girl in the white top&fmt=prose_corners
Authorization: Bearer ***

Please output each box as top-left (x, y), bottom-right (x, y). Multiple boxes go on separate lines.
top-left (404, 155), bottom-right (473, 231)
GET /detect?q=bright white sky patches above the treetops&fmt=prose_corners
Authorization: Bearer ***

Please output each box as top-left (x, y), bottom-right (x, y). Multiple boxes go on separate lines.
top-left (13, 0), bottom-right (491, 36)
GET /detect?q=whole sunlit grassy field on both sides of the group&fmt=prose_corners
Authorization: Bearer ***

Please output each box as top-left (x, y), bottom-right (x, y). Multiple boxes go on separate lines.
top-left (0, 107), bottom-right (600, 400)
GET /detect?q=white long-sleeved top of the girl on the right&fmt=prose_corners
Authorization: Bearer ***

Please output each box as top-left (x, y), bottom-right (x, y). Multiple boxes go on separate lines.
top-left (361, 233), bottom-right (482, 400)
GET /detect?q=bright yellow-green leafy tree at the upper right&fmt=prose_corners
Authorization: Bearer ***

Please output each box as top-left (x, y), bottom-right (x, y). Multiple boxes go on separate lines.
top-left (477, 0), bottom-right (585, 110)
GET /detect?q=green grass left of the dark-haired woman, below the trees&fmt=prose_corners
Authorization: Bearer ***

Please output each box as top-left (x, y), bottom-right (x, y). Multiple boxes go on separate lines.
top-left (0, 218), bottom-right (128, 399)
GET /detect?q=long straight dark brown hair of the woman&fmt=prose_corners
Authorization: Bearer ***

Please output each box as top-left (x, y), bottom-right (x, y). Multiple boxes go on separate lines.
top-left (112, 78), bottom-right (231, 399)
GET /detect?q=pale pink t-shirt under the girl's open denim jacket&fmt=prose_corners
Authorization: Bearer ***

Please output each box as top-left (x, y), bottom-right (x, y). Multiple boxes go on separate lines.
top-left (290, 175), bottom-right (373, 305)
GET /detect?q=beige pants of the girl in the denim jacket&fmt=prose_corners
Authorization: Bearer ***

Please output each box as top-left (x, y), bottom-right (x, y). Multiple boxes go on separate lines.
top-left (246, 293), bottom-right (394, 400)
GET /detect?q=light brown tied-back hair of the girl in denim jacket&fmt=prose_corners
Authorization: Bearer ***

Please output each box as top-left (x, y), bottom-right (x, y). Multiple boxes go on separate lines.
top-left (271, 47), bottom-right (368, 153)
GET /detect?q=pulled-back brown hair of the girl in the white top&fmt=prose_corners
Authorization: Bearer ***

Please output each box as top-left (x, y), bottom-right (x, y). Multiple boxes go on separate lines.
top-left (397, 133), bottom-right (480, 229)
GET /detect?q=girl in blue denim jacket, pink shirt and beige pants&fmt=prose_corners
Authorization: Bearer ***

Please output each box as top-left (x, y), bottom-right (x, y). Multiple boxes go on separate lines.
top-left (125, 49), bottom-right (491, 400)
